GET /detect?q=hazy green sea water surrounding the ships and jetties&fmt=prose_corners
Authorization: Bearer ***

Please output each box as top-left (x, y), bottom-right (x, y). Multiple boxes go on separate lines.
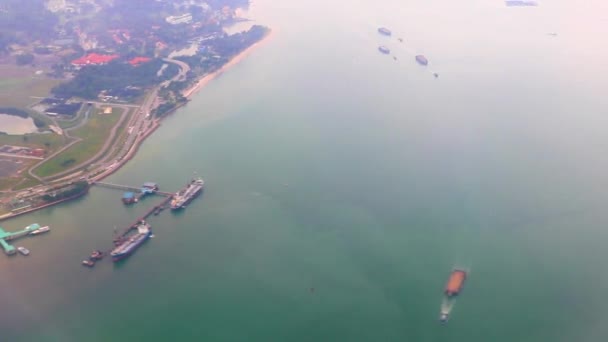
top-left (0, 0), bottom-right (608, 342)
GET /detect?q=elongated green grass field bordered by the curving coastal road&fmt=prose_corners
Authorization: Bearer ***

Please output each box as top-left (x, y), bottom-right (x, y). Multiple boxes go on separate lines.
top-left (34, 110), bottom-right (121, 177)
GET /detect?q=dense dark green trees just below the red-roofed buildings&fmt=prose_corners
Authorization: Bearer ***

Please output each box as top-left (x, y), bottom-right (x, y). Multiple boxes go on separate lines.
top-left (52, 59), bottom-right (178, 100)
